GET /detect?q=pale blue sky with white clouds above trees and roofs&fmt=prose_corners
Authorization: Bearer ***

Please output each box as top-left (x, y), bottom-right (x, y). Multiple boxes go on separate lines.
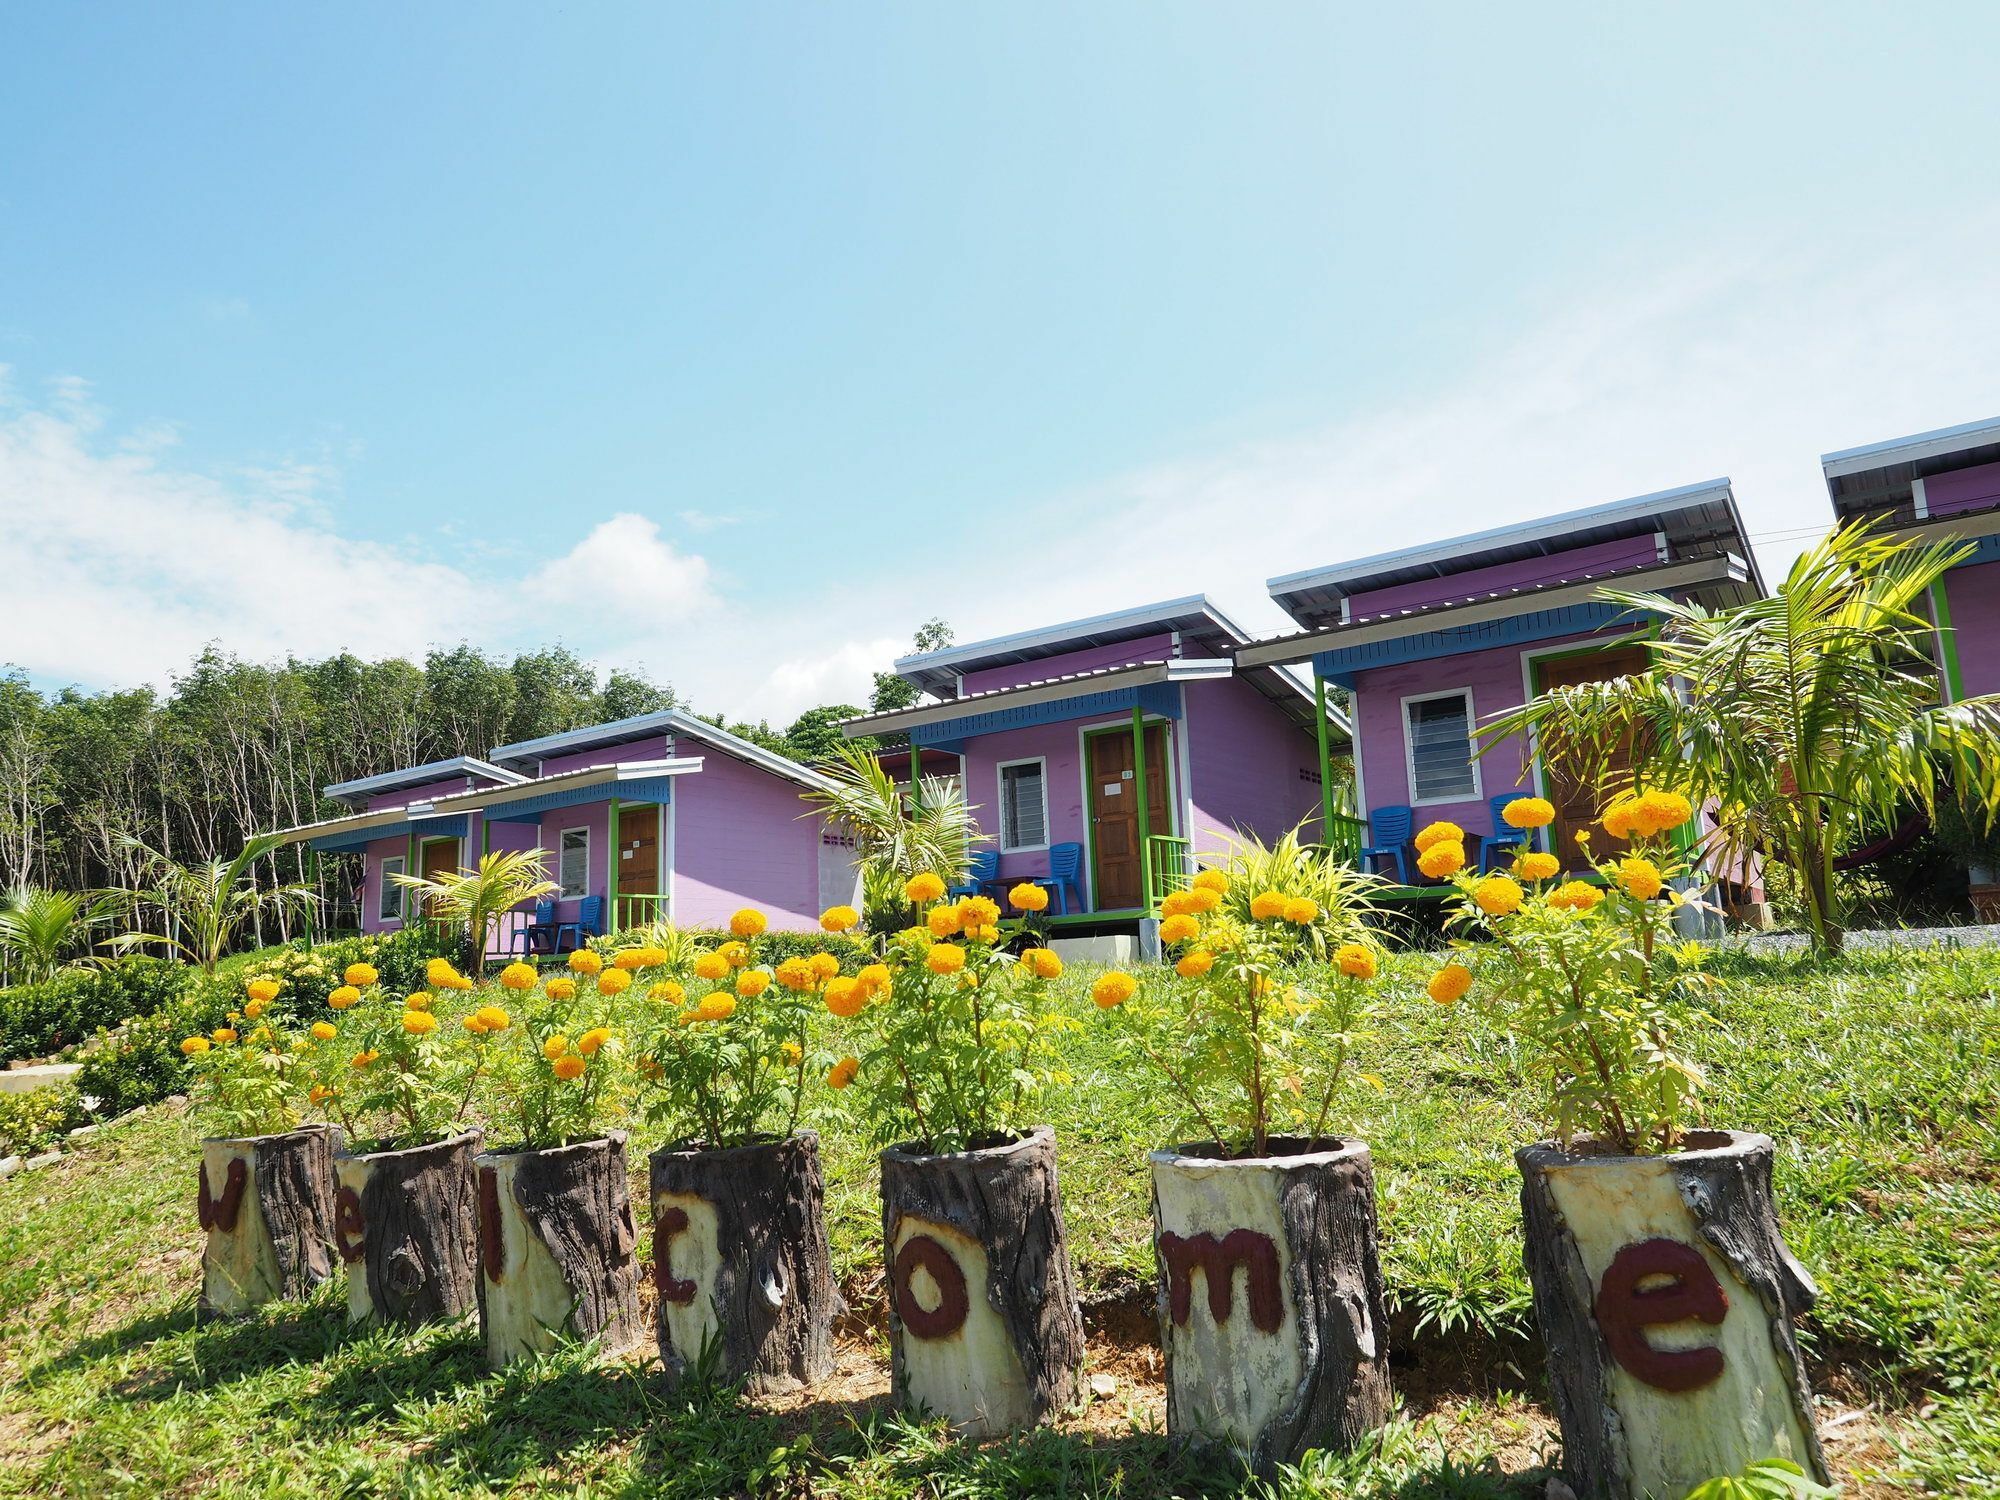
top-left (0, 4), bottom-right (2000, 718)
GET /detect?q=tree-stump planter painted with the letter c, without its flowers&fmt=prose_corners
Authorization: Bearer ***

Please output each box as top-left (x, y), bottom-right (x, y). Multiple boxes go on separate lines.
top-left (650, 1132), bottom-right (846, 1392)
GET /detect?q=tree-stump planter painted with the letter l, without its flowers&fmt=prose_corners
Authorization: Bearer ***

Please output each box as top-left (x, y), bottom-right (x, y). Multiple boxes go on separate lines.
top-left (474, 1130), bottom-right (646, 1370)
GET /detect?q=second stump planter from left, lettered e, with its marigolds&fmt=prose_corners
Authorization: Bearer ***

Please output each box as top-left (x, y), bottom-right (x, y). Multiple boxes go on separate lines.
top-left (308, 958), bottom-right (512, 1326)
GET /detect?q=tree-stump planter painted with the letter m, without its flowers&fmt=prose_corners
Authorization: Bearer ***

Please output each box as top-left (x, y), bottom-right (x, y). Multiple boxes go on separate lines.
top-left (1148, 1138), bottom-right (1390, 1474)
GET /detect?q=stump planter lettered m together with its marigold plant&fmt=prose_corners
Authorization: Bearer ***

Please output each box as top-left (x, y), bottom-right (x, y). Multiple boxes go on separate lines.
top-left (1092, 834), bottom-right (1390, 1474)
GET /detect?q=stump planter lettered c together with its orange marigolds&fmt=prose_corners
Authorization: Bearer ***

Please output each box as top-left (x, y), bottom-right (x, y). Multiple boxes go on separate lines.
top-left (614, 908), bottom-right (840, 1392)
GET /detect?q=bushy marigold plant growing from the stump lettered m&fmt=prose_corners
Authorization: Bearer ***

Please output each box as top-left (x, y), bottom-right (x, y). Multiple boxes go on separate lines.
top-left (1092, 828), bottom-right (1380, 1156)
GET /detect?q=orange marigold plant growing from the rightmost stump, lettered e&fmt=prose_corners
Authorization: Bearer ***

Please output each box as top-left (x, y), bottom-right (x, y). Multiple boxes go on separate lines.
top-left (1416, 790), bottom-right (1708, 1152)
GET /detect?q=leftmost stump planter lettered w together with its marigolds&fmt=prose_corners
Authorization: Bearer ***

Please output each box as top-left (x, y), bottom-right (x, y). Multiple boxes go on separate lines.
top-left (180, 978), bottom-right (340, 1316)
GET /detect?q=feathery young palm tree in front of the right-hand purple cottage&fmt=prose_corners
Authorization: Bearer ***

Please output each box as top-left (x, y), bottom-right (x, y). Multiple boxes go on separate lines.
top-left (1480, 524), bottom-right (2000, 950)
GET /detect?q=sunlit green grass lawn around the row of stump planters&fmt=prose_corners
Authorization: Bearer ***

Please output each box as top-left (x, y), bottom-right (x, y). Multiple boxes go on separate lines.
top-left (0, 952), bottom-right (2000, 1500)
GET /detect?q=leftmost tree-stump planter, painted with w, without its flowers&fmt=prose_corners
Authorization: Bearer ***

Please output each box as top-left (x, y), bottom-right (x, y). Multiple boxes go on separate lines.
top-left (196, 1126), bottom-right (340, 1318)
